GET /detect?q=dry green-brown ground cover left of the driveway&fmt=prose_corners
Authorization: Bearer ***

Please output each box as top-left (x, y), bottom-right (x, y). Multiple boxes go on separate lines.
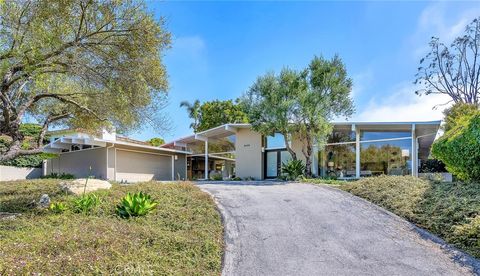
top-left (0, 179), bottom-right (223, 275)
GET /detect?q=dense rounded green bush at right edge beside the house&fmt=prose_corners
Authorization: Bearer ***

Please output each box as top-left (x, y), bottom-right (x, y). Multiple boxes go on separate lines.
top-left (432, 111), bottom-right (480, 180)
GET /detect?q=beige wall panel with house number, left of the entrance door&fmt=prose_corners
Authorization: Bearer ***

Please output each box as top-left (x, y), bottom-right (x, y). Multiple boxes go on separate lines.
top-left (235, 129), bottom-right (263, 179)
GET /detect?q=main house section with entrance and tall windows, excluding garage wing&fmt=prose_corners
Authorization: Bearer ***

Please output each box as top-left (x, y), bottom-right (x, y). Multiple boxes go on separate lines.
top-left (161, 121), bottom-right (441, 179)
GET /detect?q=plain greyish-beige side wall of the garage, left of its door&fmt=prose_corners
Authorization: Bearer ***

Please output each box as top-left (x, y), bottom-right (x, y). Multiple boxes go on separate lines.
top-left (46, 148), bottom-right (107, 179)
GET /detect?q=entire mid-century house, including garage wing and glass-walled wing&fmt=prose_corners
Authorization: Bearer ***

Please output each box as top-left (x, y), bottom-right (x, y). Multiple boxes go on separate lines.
top-left (45, 121), bottom-right (441, 182)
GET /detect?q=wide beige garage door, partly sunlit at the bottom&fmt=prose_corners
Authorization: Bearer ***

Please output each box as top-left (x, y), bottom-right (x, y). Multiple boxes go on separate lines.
top-left (116, 149), bottom-right (172, 182)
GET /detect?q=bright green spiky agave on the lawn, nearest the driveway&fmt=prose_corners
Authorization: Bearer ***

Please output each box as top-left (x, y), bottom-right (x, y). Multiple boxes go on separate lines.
top-left (117, 192), bottom-right (158, 218)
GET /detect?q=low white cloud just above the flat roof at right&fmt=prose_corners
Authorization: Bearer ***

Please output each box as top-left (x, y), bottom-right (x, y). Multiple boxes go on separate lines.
top-left (353, 84), bottom-right (450, 122)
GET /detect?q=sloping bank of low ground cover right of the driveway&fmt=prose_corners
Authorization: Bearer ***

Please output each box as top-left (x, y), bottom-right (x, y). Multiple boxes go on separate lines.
top-left (340, 176), bottom-right (480, 258)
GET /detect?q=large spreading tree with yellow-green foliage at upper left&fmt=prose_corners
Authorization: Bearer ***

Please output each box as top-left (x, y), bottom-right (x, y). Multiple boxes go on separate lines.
top-left (0, 0), bottom-right (170, 161)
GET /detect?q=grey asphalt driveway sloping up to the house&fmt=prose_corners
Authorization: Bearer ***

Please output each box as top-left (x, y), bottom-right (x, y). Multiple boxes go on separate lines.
top-left (197, 182), bottom-right (480, 275)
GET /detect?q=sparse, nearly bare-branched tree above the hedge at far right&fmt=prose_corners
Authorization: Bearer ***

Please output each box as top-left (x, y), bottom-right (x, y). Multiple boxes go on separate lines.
top-left (415, 17), bottom-right (480, 106)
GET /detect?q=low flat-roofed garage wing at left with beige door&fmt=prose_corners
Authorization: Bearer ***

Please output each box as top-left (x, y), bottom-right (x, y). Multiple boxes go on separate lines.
top-left (44, 131), bottom-right (188, 182)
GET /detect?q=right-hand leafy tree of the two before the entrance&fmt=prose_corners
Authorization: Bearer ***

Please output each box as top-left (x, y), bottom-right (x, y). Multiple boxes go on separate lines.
top-left (292, 56), bottom-right (354, 176)
